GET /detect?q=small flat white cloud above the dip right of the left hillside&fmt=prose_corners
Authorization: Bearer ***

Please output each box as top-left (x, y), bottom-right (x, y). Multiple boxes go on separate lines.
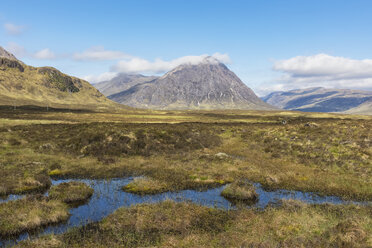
top-left (73, 46), bottom-right (132, 61)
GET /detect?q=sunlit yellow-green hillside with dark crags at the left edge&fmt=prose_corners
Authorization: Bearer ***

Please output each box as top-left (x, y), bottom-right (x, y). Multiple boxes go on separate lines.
top-left (0, 47), bottom-right (119, 109)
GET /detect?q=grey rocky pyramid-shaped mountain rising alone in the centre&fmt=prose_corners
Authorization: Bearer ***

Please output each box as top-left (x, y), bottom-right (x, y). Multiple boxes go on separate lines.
top-left (109, 57), bottom-right (273, 110)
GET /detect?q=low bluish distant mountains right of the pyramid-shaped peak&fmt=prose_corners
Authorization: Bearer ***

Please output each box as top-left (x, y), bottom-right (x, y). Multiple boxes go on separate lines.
top-left (262, 87), bottom-right (372, 112)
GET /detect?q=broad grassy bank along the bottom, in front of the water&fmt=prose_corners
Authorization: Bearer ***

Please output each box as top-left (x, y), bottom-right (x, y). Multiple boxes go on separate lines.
top-left (20, 201), bottom-right (372, 248)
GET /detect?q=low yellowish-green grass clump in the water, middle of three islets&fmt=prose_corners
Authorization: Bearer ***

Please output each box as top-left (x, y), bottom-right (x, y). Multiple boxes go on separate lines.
top-left (122, 177), bottom-right (168, 195)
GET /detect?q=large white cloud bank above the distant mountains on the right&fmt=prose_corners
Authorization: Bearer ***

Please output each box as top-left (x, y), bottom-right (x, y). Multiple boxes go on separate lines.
top-left (257, 54), bottom-right (372, 95)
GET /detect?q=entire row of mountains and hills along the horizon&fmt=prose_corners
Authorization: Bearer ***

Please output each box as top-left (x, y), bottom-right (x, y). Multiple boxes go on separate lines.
top-left (0, 43), bottom-right (372, 115)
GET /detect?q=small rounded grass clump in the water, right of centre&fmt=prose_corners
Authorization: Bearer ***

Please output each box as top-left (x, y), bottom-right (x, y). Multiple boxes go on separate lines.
top-left (221, 181), bottom-right (258, 202)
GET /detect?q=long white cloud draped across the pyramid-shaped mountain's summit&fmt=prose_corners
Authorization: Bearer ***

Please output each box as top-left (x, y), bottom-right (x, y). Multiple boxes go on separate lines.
top-left (112, 53), bottom-right (231, 74)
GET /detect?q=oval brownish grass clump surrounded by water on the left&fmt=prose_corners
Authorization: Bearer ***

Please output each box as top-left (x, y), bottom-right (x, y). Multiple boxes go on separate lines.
top-left (49, 182), bottom-right (94, 204)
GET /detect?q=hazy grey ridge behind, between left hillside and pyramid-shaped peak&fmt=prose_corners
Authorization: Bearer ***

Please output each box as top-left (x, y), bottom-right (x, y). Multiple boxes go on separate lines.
top-left (93, 73), bottom-right (157, 96)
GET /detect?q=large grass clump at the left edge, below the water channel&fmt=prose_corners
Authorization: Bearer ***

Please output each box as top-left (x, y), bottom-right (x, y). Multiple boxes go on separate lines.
top-left (0, 195), bottom-right (69, 237)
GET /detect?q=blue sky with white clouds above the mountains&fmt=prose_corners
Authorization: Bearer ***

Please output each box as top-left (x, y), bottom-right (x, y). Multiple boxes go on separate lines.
top-left (0, 0), bottom-right (372, 96)
